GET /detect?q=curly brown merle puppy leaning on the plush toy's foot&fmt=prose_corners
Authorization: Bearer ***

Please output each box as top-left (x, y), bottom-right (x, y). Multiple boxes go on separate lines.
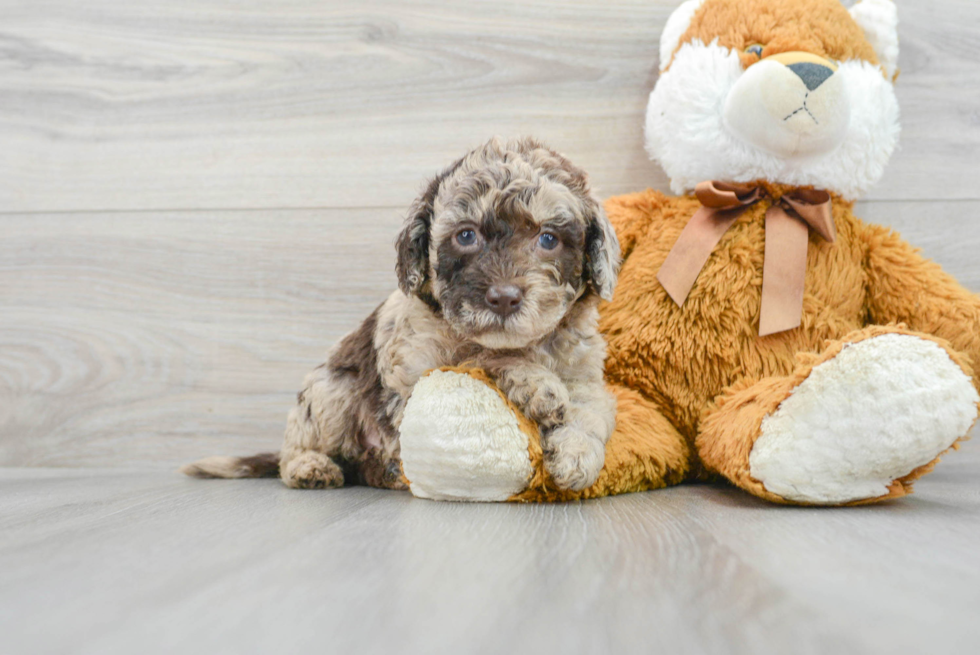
top-left (182, 139), bottom-right (619, 489)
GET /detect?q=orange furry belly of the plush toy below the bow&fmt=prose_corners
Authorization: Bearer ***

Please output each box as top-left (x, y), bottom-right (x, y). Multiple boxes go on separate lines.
top-left (600, 198), bottom-right (865, 439)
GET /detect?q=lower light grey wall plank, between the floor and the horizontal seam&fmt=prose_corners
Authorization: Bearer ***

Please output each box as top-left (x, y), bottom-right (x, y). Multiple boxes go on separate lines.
top-left (0, 202), bottom-right (980, 468)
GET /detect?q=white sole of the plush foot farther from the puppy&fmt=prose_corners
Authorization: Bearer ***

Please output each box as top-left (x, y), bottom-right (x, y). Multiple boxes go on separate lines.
top-left (749, 334), bottom-right (980, 505)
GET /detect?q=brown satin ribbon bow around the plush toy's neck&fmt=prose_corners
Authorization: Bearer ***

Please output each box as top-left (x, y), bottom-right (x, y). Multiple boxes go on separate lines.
top-left (657, 182), bottom-right (837, 337)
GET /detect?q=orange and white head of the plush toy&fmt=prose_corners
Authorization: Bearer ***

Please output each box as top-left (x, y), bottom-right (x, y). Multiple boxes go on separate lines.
top-left (646, 0), bottom-right (899, 199)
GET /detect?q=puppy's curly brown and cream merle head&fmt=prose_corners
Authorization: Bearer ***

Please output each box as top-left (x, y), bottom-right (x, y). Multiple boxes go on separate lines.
top-left (396, 139), bottom-right (619, 348)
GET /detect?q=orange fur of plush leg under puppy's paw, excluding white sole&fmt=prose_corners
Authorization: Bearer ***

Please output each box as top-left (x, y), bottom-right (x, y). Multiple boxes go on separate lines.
top-left (511, 385), bottom-right (691, 502)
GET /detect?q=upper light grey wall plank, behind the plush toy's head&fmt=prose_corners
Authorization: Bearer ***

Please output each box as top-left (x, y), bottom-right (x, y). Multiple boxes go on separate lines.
top-left (0, 0), bottom-right (980, 211)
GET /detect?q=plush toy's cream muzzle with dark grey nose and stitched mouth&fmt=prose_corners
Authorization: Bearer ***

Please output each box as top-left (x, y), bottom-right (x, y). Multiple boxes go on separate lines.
top-left (724, 52), bottom-right (851, 158)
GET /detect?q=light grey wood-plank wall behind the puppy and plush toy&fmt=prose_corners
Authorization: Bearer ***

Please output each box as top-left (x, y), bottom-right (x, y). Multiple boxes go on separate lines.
top-left (0, 0), bottom-right (980, 468)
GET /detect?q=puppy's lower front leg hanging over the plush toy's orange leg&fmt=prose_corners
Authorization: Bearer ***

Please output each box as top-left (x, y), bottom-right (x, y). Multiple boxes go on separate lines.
top-left (542, 384), bottom-right (616, 491)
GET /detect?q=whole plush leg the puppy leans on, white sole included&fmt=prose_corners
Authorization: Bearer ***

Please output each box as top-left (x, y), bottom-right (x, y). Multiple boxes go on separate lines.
top-left (401, 367), bottom-right (691, 502)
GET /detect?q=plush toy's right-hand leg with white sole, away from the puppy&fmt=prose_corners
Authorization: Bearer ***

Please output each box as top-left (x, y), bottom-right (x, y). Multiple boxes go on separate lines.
top-left (696, 326), bottom-right (980, 505)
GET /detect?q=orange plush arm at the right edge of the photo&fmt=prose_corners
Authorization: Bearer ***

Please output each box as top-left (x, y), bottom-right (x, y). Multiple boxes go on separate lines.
top-left (866, 226), bottom-right (980, 389)
